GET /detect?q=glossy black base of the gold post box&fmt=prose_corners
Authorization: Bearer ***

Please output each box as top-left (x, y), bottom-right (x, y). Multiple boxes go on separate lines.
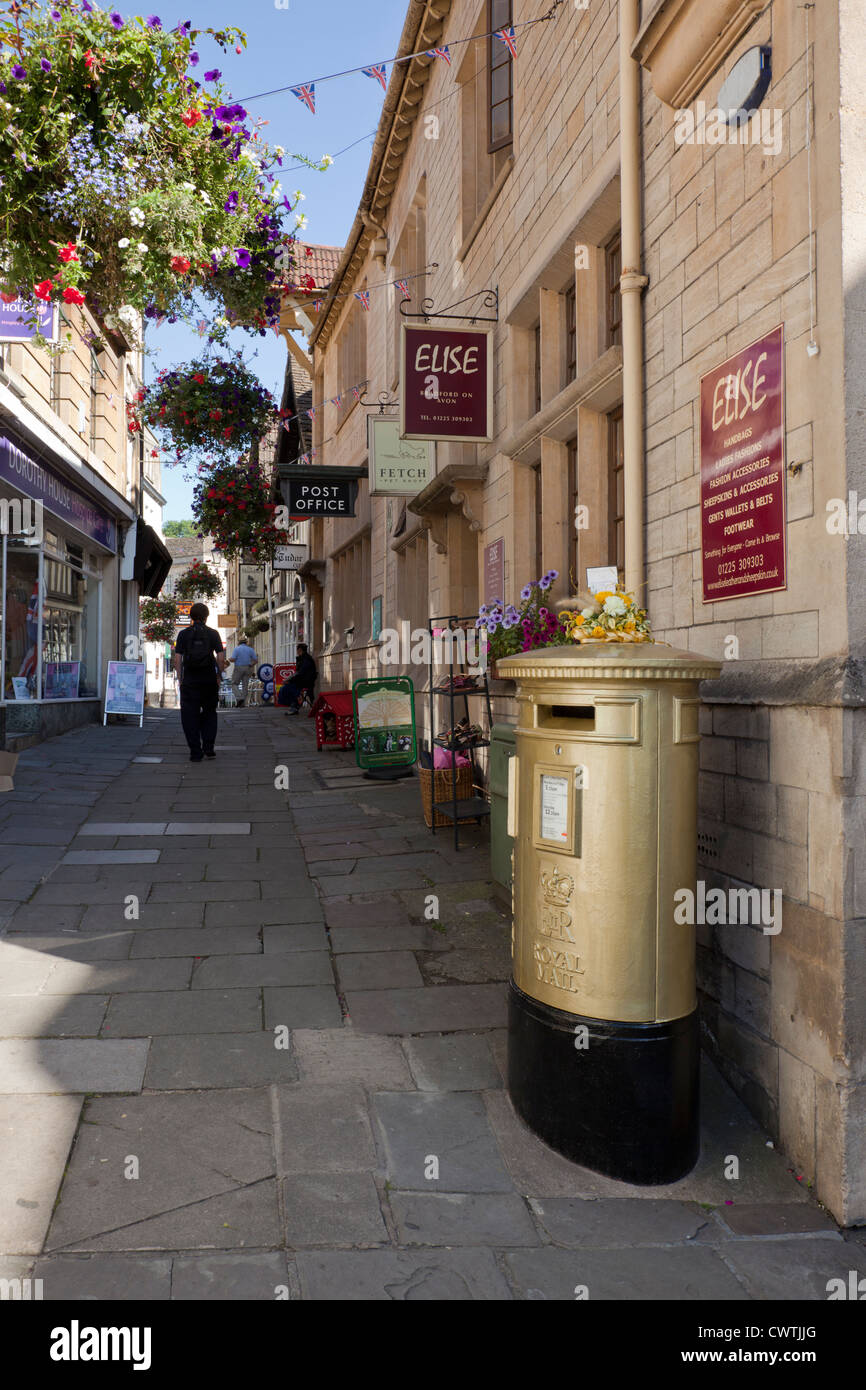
top-left (507, 980), bottom-right (701, 1186)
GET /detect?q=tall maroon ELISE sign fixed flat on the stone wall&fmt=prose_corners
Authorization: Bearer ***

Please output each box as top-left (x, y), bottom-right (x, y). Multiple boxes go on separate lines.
top-left (701, 325), bottom-right (787, 603)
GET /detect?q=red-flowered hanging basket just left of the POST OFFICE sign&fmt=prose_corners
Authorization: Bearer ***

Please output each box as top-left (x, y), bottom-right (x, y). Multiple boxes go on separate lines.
top-left (192, 464), bottom-right (285, 562)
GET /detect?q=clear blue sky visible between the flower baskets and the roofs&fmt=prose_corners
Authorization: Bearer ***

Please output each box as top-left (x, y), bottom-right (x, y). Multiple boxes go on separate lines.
top-left (147, 0), bottom-right (406, 521)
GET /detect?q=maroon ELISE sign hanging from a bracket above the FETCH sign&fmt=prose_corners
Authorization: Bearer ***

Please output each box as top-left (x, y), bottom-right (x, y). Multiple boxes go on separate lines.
top-left (400, 324), bottom-right (493, 443)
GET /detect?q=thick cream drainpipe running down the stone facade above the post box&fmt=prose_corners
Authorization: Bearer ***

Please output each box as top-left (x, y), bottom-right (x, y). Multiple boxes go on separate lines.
top-left (620, 0), bottom-right (648, 605)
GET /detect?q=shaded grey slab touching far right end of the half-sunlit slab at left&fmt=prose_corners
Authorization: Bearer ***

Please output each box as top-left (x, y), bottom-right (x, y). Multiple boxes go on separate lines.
top-left (101, 990), bottom-right (261, 1038)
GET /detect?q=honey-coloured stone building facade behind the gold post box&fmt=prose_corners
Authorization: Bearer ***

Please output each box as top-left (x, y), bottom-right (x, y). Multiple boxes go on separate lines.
top-left (296, 0), bottom-right (866, 1223)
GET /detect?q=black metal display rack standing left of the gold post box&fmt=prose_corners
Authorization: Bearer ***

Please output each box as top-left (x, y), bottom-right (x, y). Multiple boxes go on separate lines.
top-left (424, 614), bottom-right (493, 849)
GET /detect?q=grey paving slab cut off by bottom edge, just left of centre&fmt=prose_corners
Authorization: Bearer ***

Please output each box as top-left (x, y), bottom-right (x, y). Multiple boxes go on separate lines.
top-left (296, 1250), bottom-right (512, 1302)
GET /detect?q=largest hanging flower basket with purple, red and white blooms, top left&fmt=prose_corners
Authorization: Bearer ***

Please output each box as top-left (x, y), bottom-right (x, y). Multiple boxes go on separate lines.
top-left (0, 0), bottom-right (331, 342)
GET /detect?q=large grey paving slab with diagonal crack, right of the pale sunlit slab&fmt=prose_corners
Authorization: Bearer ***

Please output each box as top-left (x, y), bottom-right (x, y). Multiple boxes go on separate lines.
top-left (46, 1090), bottom-right (274, 1250)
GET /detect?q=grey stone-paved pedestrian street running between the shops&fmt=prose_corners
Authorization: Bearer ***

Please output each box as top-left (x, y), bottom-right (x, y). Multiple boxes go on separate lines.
top-left (0, 709), bottom-right (866, 1301)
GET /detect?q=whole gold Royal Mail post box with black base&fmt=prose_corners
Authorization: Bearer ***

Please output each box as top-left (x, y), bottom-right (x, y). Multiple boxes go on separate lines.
top-left (499, 642), bottom-right (720, 1183)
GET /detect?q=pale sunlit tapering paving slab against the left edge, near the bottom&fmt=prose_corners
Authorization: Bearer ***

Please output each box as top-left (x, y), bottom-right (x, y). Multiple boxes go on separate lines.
top-left (0, 1095), bottom-right (81, 1255)
